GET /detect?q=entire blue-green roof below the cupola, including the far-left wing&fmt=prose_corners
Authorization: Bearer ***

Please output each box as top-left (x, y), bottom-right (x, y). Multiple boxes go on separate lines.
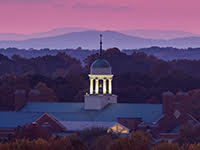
top-left (0, 102), bottom-right (162, 128)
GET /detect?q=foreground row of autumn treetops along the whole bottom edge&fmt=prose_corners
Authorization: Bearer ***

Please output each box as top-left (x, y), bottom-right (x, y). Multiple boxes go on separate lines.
top-left (0, 129), bottom-right (200, 150)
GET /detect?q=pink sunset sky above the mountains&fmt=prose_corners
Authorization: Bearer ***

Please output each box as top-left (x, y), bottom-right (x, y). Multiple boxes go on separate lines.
top-left (0, 0), bottom-right (200, 34)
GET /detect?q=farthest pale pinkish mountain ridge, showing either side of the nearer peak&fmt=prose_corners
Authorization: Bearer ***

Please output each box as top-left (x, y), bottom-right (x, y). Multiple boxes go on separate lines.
top-left (0, 27), bottom-right (200, 41)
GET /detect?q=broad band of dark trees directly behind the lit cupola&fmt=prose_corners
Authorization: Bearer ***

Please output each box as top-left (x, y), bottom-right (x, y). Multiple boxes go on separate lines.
top-left (0, 48), bottom-right (200, 103)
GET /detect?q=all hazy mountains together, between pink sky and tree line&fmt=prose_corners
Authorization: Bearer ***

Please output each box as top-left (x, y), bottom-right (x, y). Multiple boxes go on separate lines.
top-left (0, 28), bottom-right (200, 49)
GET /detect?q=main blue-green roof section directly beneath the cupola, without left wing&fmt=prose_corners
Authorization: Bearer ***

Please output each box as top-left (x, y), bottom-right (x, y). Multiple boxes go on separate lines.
top-left (20, 103), bottom-right (162, 122)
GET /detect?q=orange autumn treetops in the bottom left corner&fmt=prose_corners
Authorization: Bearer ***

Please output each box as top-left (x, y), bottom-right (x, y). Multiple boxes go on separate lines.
top-left (0, 136), bottom-right (88, 150)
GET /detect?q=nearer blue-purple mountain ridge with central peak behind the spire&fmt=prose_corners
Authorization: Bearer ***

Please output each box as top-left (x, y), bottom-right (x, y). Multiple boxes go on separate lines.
top-left (0, 30), bottom-right (200, 49)
